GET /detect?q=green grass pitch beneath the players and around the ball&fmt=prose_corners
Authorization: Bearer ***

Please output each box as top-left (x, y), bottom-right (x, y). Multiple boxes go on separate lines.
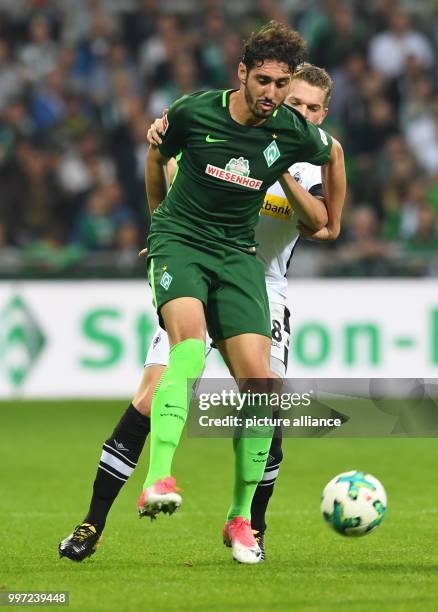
top-left (0, 402), bottom-right (438, 612)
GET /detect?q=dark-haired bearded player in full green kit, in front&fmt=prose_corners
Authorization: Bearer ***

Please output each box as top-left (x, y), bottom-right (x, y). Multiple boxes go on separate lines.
top-left (138, 23), bottom-right (345, 563)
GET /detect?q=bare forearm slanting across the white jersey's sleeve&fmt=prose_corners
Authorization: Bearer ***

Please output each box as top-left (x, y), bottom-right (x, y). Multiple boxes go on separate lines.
top-left (280, 172), bottom-right (328, 232)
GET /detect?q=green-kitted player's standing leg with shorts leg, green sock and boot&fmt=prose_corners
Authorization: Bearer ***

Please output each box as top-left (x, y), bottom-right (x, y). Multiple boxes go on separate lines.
top-left (207, 246), bottom-right (275, 563)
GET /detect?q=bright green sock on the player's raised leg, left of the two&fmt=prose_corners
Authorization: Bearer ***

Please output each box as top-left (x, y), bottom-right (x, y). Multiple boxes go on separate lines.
top-left (143, 338), bottom-right (205, 489)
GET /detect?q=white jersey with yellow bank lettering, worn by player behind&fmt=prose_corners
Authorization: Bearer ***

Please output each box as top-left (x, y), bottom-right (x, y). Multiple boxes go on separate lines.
top-left (256, 162), bottom-right (322, 304)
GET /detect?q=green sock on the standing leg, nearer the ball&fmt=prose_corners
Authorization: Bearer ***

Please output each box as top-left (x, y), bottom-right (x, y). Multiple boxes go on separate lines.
top-left (227, 411), bottom-right (274, 521)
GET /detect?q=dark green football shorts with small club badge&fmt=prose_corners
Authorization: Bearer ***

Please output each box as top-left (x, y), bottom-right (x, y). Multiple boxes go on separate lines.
top-left (148, 233), bottom-right (271, 342)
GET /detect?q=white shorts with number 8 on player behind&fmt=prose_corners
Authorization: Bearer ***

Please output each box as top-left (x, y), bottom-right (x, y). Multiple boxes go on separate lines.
top-left (144, 302), bottom-right (290, 378)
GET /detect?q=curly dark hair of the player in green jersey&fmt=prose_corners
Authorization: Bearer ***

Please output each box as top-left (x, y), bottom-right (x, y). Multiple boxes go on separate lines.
top-left (242, 21), bottom-right (307, 72)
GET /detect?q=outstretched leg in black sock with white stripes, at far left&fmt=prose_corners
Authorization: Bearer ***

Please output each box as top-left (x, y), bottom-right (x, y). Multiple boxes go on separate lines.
top-left (59, 328), bottom-right (169, 561)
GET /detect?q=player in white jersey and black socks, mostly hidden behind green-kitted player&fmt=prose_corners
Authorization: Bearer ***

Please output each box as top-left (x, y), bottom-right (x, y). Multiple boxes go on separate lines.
top-left (59, 64), bottom-right (342, 561)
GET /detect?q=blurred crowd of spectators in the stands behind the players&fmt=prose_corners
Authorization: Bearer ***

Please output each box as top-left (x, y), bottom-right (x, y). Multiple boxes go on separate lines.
top-left (0, 0), bottom-right (438, 276)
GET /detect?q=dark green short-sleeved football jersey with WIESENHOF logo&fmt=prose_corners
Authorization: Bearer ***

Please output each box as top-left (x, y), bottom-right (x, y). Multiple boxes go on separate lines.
top-left (150, 90), bottom-right (332, 250)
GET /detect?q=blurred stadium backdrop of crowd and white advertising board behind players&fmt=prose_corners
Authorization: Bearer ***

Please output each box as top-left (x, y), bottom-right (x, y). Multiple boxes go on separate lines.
top-left (0, 0), bottom-right (438, 397)
